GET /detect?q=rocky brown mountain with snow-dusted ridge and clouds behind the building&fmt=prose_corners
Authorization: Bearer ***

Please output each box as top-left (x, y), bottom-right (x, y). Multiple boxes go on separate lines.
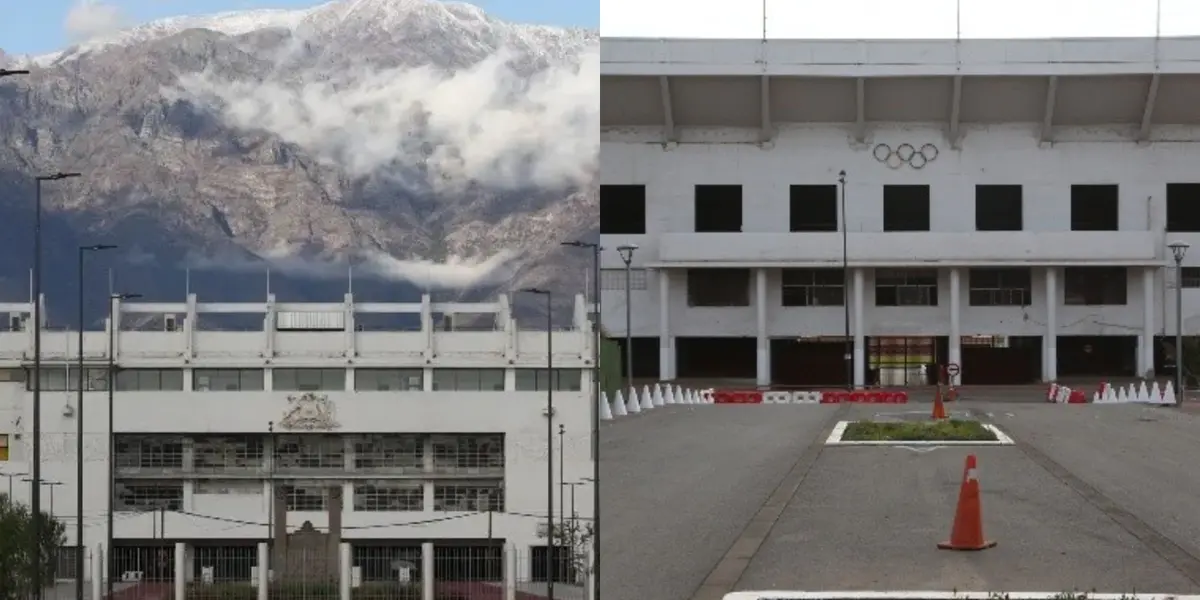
top-left (0, 0), bottom-right (599, 324)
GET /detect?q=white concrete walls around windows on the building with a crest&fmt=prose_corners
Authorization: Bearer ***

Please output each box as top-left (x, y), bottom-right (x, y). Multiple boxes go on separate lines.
top-left (0, 295), bottom-right (593, 564)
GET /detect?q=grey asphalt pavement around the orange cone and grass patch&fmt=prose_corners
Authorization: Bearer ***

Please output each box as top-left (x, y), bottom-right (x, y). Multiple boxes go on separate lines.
top-left (601, 395), bottom-right (1200, 600)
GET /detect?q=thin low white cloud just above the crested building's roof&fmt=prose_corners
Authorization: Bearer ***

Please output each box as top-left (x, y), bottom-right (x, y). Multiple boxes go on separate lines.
top-left (184, 246), bottom-right (521, 289)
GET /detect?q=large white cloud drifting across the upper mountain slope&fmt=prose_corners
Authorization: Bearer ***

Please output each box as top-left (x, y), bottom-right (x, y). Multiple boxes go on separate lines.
top-left (175, 47), bottom-right (600, 190)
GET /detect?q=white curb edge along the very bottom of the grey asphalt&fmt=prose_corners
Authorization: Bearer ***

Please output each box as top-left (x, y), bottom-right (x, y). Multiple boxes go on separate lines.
top-left (722, 592), bottom-right (1200, 600)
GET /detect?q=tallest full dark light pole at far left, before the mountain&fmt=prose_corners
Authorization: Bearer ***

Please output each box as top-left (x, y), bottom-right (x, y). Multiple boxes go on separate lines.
top-left (29, 173), bottom-right (80, 600)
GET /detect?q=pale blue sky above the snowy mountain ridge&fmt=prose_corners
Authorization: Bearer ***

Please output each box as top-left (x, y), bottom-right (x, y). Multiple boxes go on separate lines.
top-left (0, 0), bottom-right (600, 54)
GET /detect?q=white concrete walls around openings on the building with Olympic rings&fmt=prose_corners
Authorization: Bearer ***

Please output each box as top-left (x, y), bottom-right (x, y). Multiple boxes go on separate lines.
top-left (600, 38), bottom-right (1200, 384)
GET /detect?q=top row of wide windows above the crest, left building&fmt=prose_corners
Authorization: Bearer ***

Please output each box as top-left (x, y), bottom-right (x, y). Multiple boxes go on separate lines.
top-left (16, 365), bottom-right (583, 391)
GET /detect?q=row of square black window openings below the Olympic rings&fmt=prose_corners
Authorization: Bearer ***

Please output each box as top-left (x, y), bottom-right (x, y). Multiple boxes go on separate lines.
top-left (600, 184), bottom-right (1200, 234)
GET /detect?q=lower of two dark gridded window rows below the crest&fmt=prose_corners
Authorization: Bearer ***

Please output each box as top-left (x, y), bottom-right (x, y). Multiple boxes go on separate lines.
top-left (114, 479), bottom-right (504, 512)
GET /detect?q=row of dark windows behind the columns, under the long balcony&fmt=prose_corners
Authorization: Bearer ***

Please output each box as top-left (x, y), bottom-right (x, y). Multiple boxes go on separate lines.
top-left (688, 266), bottom-right (1137, 307)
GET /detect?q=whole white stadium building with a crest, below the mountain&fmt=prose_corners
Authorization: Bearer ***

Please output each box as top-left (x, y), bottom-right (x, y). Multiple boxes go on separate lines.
top-left (0, 294), bottom-right (593, 581)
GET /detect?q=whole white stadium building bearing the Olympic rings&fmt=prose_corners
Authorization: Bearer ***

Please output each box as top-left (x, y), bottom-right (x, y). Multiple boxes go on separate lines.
top-left (600, 38), bottom-right (1200, 385)
